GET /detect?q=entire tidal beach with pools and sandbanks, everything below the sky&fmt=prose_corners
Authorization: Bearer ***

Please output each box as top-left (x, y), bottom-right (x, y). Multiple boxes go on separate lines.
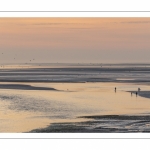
top-left (0, 64), bottom-right (150, 133)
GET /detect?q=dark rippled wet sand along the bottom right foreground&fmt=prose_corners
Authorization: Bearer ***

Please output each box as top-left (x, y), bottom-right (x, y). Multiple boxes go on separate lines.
top-left (31, 115), bottom-right (150, 133)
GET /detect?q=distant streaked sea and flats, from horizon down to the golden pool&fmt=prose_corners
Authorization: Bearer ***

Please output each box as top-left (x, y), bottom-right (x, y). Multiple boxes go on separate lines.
top-left (0, 64), bottom-right (150, 83)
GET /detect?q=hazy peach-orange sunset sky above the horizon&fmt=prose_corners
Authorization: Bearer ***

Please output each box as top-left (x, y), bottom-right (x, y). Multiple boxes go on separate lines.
top-left (0, 18), bottom-right (150, 64)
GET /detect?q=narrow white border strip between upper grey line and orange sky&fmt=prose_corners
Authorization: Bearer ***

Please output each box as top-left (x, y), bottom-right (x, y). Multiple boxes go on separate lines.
top-left (0, 11), bottom-right (150, 17)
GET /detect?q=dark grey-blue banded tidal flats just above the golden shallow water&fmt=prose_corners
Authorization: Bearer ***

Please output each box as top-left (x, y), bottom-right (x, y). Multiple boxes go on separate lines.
top-left (0, 66), bottom-right (150, 84)
